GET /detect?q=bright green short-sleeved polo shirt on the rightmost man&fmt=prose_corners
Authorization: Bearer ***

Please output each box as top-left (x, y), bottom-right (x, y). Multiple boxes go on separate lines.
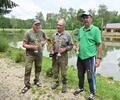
top-left (78, 25), bottom-right (101, 60)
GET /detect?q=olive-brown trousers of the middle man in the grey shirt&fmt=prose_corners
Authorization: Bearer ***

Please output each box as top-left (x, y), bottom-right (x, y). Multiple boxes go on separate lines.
top-left (52, 53), bottom-right (68, 84)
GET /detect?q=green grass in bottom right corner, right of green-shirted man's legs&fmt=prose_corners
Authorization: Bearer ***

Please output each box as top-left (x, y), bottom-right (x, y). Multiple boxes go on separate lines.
top-left (96, 76), bottom-right (120, 100)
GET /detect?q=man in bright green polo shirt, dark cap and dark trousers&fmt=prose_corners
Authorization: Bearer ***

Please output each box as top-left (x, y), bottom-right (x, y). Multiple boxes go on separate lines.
top-left (74, 14), bottom-right (102, 100)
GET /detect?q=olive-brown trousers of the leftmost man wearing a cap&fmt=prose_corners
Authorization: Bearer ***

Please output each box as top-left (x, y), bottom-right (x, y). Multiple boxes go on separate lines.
top-left (24, 54), bottom-right (42, 86)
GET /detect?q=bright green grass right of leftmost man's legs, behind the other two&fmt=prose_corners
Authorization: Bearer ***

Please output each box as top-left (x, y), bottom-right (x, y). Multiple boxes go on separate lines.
top-left (43, 58), bottom-right (120, 100)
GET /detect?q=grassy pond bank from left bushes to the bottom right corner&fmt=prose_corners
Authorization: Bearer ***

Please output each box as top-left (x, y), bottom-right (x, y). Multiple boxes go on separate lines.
top-left (0, 48), bottom-right (120, 100)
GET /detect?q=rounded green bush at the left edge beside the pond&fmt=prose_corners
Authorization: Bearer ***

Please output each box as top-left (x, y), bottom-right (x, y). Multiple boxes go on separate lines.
top-left (0, 37), bottom-right (9, 52)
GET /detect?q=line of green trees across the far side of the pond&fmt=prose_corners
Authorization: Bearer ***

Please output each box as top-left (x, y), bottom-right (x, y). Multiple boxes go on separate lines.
top-left (0, 4), bottom-right (120, 30)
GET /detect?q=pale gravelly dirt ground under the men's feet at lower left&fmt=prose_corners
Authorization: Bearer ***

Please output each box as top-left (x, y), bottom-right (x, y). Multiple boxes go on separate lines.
top-left (0, 58), bottom-right (85, 100)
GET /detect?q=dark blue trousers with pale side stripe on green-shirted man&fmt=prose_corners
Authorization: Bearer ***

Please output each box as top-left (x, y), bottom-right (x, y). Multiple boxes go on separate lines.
top-left (77, 57), bottom-right (96, 94)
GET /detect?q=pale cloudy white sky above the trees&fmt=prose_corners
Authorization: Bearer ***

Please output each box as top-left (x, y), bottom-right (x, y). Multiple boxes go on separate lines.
top-left (6, 0), bottom-right (120, 19)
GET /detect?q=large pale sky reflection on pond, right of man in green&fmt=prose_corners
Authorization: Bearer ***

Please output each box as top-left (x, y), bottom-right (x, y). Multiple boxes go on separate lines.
top-left (97, 49), bottom-right (120, 80)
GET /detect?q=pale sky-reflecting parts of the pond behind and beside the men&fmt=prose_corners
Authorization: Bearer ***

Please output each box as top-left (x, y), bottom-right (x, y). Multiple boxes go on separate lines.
top-left (12, 42), bottom-right (120, 80)
